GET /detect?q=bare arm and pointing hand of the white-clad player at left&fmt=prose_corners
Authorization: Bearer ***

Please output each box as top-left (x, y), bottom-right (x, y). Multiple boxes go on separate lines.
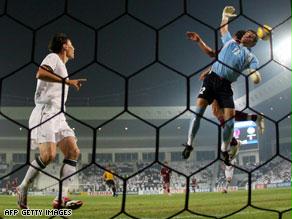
top-left (36, 65), bottom-right (86, 90)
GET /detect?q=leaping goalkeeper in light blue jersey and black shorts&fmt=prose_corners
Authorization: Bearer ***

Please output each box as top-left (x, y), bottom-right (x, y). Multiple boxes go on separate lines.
top-left (182, 6), bottom-right (260, 165)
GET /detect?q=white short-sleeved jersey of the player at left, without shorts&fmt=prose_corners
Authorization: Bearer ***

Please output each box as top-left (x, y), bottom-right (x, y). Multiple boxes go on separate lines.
top-left (34, 53), bottom-right (69, 111)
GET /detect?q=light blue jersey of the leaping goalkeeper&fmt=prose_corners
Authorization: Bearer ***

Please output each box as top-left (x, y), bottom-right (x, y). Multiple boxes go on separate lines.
top-left (212, 32), bottom-right (259, 82)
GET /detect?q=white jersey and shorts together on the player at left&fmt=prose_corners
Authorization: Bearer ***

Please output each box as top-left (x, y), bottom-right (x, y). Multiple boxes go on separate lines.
top-left (29, 53), bottom-right (75, 149)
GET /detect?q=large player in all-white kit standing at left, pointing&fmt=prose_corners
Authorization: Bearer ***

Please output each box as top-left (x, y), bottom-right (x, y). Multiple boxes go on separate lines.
top-left (17, 33), bottom-right (86, 209)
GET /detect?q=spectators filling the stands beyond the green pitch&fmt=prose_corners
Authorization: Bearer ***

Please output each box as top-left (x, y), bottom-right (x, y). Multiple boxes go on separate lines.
top-left (0, 158), bottom-right (292, 194)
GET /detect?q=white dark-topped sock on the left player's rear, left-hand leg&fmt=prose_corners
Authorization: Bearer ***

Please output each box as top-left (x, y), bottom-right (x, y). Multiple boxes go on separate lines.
top-left (20, 156), bottom-right (46, 188)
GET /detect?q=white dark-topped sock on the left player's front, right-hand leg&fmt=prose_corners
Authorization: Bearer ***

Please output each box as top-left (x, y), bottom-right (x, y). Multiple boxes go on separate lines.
top-left (60, 159), bottom-right (77, 197)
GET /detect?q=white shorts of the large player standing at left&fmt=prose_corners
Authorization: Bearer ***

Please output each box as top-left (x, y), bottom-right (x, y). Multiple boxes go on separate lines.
top-left (29, 104), bottom-right (75, 149)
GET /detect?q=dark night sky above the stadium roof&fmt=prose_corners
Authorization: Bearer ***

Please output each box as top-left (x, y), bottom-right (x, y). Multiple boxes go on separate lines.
top-left (0, 0), bottom-right (292, 118)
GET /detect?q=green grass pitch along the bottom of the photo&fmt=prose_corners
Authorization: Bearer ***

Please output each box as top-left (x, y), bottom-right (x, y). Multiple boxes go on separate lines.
top-left (0, 188), bottom-right (292, 219)
